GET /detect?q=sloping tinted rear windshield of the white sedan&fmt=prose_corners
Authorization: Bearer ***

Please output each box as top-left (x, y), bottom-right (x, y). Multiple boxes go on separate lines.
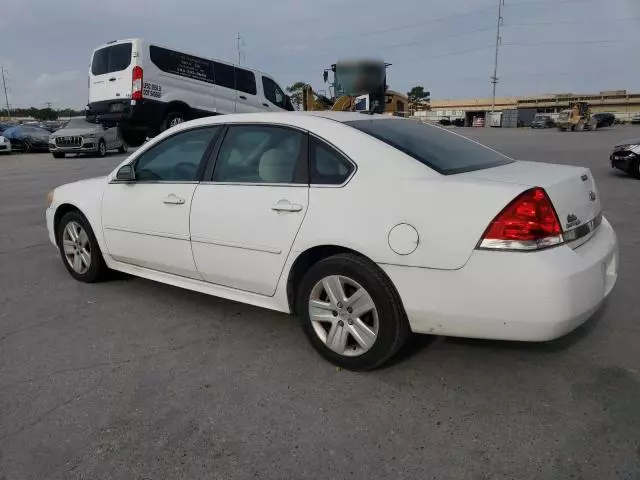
top-left (345, 118), bottom-right (513, 175)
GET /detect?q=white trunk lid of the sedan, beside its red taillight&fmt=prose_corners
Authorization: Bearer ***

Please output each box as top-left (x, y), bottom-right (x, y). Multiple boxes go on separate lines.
top-left (462, 161), bottom-right (601, 242)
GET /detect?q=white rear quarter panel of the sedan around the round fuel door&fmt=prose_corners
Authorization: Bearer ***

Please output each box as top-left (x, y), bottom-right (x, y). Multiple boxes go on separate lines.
top-left (292, 123), bottom-right (526, 269)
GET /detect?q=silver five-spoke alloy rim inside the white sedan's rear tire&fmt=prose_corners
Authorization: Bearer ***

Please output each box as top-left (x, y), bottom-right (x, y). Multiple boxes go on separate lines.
top-left (309, 275), bottom-right (379, 357)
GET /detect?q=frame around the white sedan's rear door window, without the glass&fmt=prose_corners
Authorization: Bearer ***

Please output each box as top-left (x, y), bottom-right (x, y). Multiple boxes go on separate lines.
top-left (200, 122), bottom-right (309, 187)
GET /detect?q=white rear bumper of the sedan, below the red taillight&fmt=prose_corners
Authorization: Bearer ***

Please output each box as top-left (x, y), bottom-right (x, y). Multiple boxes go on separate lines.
top-left (381, 218), bottom-right (618, 341)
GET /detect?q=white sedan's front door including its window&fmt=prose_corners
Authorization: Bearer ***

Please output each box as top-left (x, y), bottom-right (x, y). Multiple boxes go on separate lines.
top-left (102, 126), bottom-right (220, 279)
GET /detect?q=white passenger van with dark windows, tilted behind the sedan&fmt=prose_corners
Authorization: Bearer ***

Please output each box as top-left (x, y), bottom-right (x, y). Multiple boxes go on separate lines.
top-left (86, 38), bottom-right (294, 146)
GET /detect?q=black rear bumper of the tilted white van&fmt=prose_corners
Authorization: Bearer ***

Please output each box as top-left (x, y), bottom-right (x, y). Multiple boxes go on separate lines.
top-left (85, 99), bottom-right (166, 128)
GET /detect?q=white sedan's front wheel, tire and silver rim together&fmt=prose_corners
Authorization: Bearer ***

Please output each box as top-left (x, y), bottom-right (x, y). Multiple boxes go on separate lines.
top-left (56, 212), bottom-right (108, 283)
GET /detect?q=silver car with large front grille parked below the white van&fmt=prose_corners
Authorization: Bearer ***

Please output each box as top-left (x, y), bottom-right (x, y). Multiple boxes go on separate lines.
top-left (49, 117), bottom-right (127, 158)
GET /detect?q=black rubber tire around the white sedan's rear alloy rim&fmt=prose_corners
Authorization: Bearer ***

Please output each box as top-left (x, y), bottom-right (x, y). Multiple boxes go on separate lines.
top-left (296, 253), bottom-right (409, 371)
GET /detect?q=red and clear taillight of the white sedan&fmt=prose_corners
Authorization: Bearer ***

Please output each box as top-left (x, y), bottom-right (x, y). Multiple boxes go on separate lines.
top-left (478, 187), bottom-right (564, 250)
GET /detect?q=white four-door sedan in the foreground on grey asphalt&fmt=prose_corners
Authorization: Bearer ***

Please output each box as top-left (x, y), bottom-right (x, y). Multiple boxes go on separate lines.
top-left (46, 112), bottom-right (618, 370)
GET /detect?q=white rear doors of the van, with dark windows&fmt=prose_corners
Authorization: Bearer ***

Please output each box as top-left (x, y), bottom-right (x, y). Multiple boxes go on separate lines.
top-left (89, 41), bottom-right (133, 104)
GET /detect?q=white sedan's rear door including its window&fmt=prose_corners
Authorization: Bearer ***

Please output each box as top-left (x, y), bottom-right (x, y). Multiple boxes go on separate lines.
top-left (191, 125), bottom-right (309, 296)
